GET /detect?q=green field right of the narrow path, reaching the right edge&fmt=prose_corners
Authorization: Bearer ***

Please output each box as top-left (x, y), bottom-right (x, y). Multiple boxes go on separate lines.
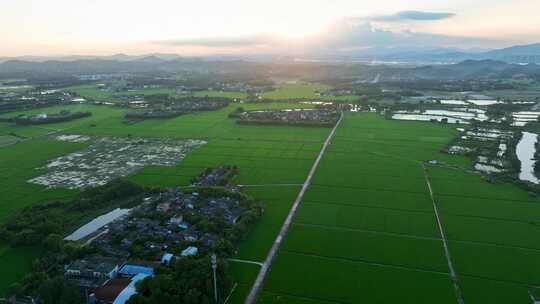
top-left (429, 167), bottom-right (540, 303)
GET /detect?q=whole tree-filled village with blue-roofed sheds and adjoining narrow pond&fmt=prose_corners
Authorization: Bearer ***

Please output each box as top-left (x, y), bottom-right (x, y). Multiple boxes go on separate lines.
top-left (17, 166), bottom-right (263, 304)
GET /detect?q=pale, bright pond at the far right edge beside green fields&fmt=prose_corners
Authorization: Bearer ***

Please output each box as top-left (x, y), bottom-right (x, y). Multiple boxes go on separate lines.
top-left (516, 132), bottom-right (539, 184)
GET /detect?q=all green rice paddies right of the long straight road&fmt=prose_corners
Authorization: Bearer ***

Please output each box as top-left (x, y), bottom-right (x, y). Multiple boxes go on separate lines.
top-left (259, 114), bottom-right (540, 303)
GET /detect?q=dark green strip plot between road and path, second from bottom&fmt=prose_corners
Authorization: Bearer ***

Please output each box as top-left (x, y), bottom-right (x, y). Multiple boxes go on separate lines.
top-left (282, 224), bottom-right (447, 272)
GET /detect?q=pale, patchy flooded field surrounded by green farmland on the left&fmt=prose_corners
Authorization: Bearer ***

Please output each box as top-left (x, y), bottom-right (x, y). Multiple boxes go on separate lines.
top-left (29, 135), bottom-right (206, 189)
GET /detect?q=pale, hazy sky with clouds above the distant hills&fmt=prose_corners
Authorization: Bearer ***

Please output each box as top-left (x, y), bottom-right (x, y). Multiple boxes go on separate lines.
top-left (0, 0), bottom-right (540, 56)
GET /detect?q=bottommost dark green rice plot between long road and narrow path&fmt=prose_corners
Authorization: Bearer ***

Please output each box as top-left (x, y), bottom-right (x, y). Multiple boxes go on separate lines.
top-left (260, 252), bottom-right (455, 304)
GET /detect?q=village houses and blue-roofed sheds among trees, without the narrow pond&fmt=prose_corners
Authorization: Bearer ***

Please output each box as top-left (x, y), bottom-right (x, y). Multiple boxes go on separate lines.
top-left (64, 166), bottom-right (247, 304)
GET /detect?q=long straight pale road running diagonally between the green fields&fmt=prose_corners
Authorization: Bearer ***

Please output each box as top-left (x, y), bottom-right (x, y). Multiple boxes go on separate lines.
top-left (245, 112), bottom-right (343, 304)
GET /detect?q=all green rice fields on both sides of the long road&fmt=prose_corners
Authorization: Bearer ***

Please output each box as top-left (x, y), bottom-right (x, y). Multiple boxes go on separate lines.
top-left (0, 103), bottom-right (540, 304)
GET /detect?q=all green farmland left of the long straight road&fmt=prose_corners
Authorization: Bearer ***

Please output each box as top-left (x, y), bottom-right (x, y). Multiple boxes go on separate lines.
top-left (0, 103), bottom-right (328, 303)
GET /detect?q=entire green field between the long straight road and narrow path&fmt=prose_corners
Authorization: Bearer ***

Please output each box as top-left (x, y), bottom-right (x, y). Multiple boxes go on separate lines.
top-left (259, 114), bottom-right (456, 303)
